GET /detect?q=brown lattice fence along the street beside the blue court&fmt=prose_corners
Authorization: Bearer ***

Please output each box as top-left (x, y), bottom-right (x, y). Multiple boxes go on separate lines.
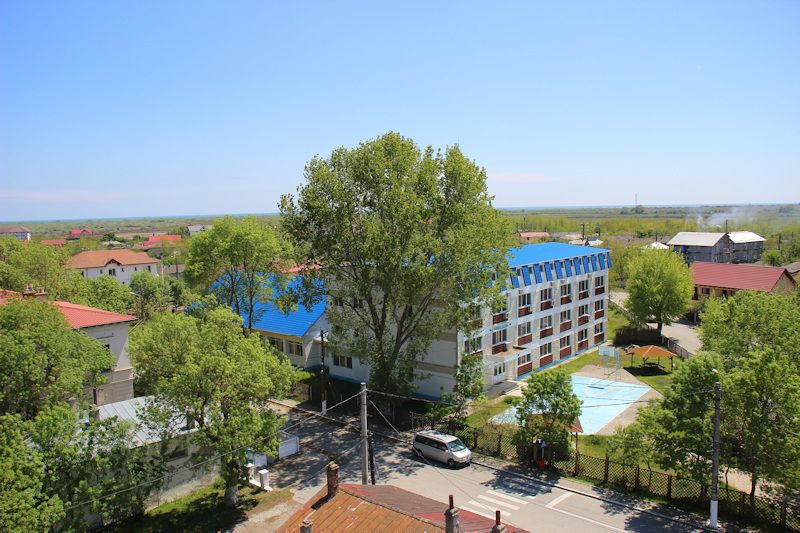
top-left (412, 416), bottom-right (800, 531)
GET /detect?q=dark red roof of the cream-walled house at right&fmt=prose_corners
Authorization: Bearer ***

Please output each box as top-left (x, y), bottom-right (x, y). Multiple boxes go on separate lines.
top-left (692, 261), bottom-right (790, 292)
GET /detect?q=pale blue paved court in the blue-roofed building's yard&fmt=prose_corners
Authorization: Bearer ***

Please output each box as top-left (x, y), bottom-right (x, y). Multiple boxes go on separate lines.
top-left (490, 376), bottom-right (650, 435)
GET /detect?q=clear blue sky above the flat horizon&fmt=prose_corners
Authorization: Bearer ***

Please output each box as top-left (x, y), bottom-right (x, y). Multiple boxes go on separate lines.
top-left (0, 0), bottom-right (800, 220)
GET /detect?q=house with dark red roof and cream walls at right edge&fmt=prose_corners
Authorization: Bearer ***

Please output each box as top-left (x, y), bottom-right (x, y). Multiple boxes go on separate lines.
top-left (691, 261), bottom-right (796, 299)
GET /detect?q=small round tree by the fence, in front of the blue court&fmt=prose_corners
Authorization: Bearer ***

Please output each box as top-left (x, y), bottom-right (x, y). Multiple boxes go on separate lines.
top-left (514, 370), bottom-right (581, 460)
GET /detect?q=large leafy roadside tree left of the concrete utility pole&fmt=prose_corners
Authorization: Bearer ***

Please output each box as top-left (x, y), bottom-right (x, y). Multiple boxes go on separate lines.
top-left (130, 308), bottom-right (298, 506)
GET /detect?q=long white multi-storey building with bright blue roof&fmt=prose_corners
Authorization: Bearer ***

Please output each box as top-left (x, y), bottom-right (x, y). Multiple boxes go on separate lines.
top-left (254, 242), bottom-right (611, 398)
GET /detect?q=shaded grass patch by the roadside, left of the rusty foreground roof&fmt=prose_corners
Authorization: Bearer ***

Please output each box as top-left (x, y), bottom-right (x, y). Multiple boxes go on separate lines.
top-left (105, 484), bottom-right (292, 533)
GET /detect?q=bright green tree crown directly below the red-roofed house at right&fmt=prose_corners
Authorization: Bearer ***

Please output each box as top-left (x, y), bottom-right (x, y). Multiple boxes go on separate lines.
top-left (700, 291), bottom-right (800, 370)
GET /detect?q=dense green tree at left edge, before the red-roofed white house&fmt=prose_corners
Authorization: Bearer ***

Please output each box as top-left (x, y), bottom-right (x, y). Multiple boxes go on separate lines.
top-left (0, 300), bottom-right (114, 419)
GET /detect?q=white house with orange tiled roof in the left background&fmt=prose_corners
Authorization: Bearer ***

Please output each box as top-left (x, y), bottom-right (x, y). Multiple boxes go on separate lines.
top-left (67, 250), bottom-right (161, 285)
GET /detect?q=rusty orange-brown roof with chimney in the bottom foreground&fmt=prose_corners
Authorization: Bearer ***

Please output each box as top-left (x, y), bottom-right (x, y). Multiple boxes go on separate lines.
top-left (277, 483), bottom-right (526, 533)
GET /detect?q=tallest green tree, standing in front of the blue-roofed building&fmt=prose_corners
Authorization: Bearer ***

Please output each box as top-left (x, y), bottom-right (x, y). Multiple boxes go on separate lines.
top-left (281, 133), bottom-right (511, 394)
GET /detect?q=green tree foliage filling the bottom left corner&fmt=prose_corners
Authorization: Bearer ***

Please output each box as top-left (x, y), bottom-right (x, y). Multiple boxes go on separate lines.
top-left (0, 415), bottom-right (64, 531)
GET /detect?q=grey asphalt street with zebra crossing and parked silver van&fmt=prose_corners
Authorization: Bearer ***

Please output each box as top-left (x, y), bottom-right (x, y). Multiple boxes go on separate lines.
top-left (272, 412), bottom-right (700, 533)
